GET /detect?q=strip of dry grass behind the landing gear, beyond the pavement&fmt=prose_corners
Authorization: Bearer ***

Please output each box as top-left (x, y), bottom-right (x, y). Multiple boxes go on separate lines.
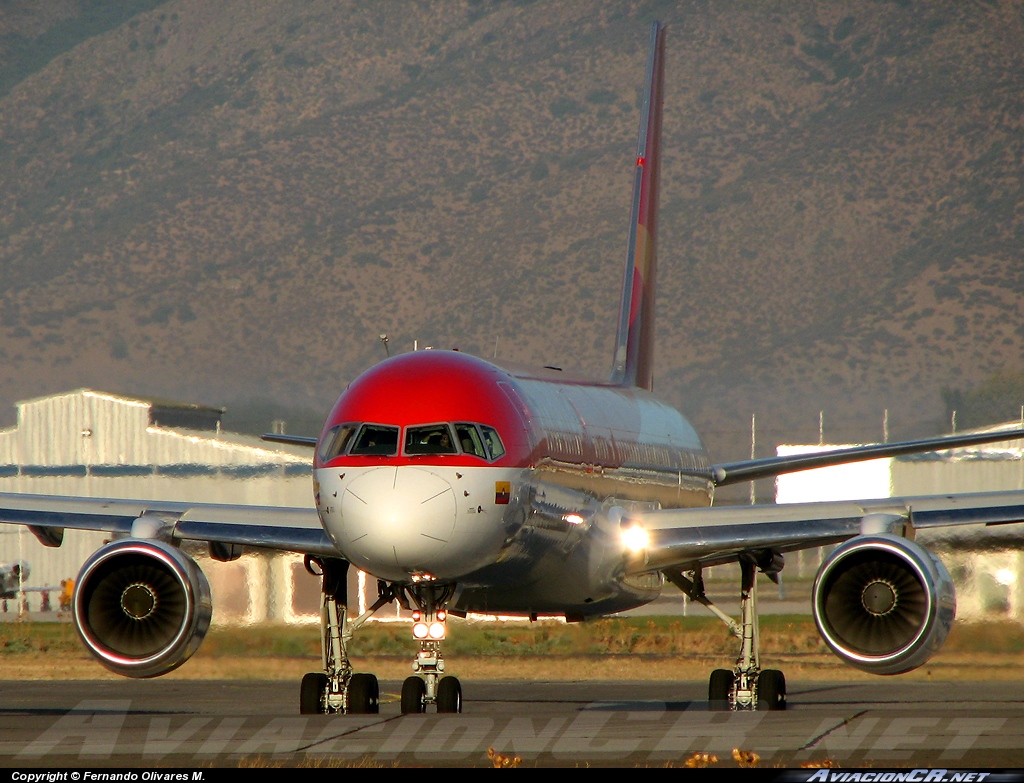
top-left (0, 617), bottom-right (1024, 681)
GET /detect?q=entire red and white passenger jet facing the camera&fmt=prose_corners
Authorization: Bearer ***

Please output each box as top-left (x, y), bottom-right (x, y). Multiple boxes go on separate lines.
top-left (0, 24), bottom-right (1024, 713)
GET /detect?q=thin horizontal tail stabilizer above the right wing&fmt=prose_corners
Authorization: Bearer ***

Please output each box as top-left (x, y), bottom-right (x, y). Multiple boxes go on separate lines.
top-left (711, 430), bottom-right (1024, 486)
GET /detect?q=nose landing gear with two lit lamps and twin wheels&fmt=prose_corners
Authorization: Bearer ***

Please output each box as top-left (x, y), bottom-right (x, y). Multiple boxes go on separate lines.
top-left (401, 583), bottom-right (462, 714)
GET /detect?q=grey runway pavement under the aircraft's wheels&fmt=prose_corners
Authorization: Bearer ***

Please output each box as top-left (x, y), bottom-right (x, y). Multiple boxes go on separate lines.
top-left (0, 678), bottom-right (1024, 769)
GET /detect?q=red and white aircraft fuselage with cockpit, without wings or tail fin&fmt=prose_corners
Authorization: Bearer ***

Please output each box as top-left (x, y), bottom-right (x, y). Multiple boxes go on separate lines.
top-left (314, 350), bottom-right (713, 616)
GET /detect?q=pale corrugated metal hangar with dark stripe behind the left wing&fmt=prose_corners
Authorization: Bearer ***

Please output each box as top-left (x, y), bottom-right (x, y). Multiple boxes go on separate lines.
top-left (0, 390), bottom-right (318, 621)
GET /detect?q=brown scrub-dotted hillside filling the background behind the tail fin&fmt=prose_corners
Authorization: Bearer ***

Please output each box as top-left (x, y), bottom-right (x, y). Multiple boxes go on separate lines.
top-left (0, 0), bottom-right (1024, 470)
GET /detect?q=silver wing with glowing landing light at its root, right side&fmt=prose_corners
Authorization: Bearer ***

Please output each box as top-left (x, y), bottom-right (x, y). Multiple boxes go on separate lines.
top-left (624, 490), bottom-right (1024, 572)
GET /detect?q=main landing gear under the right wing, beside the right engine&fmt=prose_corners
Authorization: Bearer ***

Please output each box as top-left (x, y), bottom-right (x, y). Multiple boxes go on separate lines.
top-left (665, 551), bottom-right (785, 710)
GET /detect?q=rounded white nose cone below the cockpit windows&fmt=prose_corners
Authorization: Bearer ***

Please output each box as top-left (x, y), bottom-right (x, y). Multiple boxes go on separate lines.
top-left (341, 466), bottom-right (456, 573)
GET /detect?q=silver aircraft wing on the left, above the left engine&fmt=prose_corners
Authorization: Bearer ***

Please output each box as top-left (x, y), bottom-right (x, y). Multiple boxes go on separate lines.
top-left (0, 492), bottom-right (338, 556)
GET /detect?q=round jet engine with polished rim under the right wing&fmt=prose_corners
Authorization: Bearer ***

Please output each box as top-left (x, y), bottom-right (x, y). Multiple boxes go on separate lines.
top-left (813, 534), bottom-right (956, 675)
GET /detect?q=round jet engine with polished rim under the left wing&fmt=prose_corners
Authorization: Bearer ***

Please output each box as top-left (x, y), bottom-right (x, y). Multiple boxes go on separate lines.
top-left (73, 538), bottom-right (212, 678)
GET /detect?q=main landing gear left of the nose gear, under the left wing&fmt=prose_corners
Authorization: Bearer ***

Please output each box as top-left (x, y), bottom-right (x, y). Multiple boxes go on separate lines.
top-left (299, 556), bottom-right (394, 714)
